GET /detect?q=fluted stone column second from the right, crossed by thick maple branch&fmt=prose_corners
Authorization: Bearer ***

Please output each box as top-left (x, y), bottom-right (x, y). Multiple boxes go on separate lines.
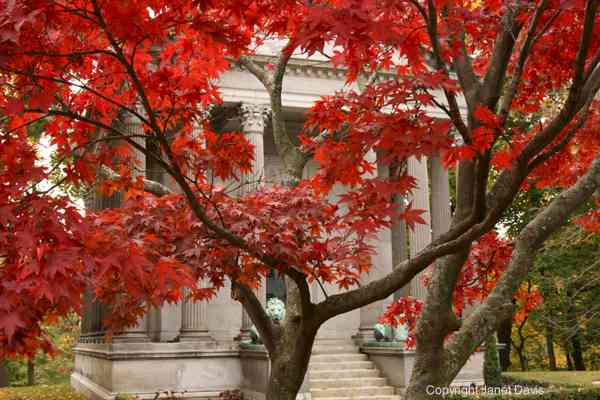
top-left (408, 157), bottom-right (431, 300)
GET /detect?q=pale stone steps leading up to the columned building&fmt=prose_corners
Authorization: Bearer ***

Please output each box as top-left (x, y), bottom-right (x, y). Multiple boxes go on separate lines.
top-left (308, 340), bottom-right (400, 400)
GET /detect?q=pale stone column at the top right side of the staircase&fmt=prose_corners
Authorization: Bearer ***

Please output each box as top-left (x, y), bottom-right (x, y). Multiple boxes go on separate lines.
top-left (355, 151), bottom-right (392, 342)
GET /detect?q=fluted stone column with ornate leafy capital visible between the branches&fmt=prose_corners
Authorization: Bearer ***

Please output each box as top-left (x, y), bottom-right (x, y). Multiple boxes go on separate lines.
top-left (238, 103), bottom-right (269, 341)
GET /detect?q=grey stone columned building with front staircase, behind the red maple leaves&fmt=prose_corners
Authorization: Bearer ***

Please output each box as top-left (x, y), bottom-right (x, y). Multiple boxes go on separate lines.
top-left (71, 43), bottom-right (481, 400)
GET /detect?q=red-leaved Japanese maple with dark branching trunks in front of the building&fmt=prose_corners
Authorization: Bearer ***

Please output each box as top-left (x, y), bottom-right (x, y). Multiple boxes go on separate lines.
top-left (0, 0), bottom-right (600, 399)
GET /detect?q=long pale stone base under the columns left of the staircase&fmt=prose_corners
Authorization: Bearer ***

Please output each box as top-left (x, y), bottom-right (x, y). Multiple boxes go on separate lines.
top-left (71, 342), bottom-right (242, 400)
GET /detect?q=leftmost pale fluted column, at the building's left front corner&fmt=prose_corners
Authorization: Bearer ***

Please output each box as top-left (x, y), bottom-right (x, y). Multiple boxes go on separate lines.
top-left (113, 113), bottom-right (150, 343)
